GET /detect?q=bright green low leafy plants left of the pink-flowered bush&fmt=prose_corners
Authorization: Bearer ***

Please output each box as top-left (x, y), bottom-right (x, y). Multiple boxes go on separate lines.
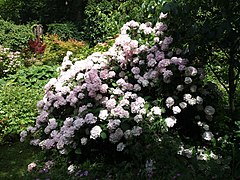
top-left (0, 66), bottom-right (57, 143)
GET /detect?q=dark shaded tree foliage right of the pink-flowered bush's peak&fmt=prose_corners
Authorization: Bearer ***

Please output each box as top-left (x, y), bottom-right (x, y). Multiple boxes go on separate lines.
top-left (163, 0), bottom-right (240, 114)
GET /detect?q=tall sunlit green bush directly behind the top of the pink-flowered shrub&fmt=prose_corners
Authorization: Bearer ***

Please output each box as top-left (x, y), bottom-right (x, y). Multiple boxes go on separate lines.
top-left (83, 0), bottom-right (164, 45)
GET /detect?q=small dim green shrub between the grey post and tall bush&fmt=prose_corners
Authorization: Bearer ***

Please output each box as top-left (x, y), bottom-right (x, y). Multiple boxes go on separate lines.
top-left (47, 22), bottom-right (79, 41)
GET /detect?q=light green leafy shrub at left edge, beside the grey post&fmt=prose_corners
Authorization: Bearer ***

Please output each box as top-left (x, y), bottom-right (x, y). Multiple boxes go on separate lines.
top-left (0, 19), bottom-right (34, 50)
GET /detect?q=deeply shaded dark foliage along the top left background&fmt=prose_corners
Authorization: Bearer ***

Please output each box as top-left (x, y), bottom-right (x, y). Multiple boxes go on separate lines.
top-left (0, 0), bottom-right (87, 24)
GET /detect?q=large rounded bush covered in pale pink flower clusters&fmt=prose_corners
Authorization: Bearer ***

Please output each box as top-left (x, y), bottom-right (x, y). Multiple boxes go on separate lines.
top-left (20, 14), bottom-right (215, 158)
